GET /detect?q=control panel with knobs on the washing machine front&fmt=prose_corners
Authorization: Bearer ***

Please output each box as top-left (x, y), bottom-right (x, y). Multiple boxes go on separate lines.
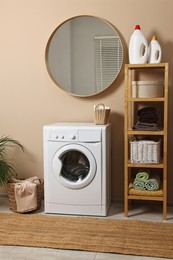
top-left (49, 130), bottom-right (78, 142)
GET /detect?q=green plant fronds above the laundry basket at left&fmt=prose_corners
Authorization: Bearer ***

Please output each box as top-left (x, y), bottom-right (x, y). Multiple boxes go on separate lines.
top-left (0, 136), bottom-right (23, 185)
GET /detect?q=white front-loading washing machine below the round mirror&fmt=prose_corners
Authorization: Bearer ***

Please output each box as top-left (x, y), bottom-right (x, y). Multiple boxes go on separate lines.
top-left (43, 123), bottom-right (111, 216)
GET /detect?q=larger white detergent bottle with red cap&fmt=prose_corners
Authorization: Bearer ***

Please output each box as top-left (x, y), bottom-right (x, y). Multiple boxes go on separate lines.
top-left (129, 25), bottom-right (148, 64)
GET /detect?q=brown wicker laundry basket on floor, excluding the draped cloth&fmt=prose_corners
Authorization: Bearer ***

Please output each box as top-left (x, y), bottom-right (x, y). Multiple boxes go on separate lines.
top-left (7, 179), bottom-right (44, 212)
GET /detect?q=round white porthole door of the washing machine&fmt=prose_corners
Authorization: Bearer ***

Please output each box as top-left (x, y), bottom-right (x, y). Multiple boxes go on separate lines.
top-left (52, 144), bottom-right (96, 189)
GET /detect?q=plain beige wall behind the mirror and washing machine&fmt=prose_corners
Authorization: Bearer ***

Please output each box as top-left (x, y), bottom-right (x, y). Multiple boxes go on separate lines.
top-left (0, 0), bottom-right (173, 200)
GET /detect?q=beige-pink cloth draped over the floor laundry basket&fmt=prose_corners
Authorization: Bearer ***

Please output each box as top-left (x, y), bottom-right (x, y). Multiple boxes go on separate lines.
top-left (14, 177), bottom-right (40, 213)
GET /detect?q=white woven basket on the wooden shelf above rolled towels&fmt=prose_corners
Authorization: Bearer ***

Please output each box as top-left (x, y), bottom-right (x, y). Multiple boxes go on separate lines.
top-left (130, 139), bottom-right (161, 163)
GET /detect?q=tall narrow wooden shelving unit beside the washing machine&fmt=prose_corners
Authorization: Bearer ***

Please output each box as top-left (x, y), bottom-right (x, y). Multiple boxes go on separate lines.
top-left (124, 63), bottom-right (168, 220)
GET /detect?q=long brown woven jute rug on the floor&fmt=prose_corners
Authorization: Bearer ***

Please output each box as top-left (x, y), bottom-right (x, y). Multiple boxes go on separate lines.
top-left (0, 213), bottom-right (173, 258)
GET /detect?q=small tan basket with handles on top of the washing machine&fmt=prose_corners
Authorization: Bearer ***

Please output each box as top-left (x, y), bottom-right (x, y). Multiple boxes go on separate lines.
top-left (94, 104), bottom-right (111, 125)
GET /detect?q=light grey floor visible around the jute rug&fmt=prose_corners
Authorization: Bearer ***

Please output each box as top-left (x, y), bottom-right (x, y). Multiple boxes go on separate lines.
top-left (0, 195), bottom-right (173, 260)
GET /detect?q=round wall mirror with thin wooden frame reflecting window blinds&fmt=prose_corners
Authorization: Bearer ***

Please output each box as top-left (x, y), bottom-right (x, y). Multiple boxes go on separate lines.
top-left (46, 15), bottom-right (123, 97)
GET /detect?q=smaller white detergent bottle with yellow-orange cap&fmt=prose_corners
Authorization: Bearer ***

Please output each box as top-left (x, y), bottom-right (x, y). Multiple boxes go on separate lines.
top-left (148, 35), bottom-right (162, 63)
